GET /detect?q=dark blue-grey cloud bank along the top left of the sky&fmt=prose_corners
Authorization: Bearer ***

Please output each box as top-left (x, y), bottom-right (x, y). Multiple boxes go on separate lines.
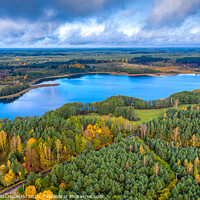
top-left (0, 0), bottom-right (132, 21)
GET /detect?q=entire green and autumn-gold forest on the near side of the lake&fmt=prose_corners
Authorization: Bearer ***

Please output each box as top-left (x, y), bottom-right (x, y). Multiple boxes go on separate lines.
top-left (0, 91), bottom-right (200, 200)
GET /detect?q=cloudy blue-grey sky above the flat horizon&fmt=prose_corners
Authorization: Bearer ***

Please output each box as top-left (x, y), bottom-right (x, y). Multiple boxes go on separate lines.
top-left (0, 0), bottom-right (200, 48)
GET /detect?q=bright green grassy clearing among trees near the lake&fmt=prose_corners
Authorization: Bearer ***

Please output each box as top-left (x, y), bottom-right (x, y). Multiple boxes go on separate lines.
top-left (135, 105), bottom-right (189, 124)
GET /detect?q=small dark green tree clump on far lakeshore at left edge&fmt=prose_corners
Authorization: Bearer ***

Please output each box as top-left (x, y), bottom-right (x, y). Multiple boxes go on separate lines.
top-left (0, 84), bottom-right (30, 97)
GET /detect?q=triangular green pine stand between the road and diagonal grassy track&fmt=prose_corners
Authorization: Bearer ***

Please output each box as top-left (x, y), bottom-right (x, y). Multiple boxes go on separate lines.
top-left (22, 138), bottom-right (174, 199)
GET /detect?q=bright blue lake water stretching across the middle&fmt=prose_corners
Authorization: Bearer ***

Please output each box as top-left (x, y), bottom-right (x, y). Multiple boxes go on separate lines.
top-left (0, 75), bottom-right (200, 120)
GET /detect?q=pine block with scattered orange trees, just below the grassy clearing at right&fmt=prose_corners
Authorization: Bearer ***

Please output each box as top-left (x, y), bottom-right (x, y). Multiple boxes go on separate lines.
top-left (146, 105), bottom-right (200, 147)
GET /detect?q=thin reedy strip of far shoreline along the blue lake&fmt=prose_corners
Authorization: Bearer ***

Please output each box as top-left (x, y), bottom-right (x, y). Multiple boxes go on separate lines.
top-left (0, 72), bottom-right (199, 99)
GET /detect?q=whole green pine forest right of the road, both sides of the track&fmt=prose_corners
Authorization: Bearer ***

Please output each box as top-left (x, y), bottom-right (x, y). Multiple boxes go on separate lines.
top-left (19, 105), bottom-right (200, 200)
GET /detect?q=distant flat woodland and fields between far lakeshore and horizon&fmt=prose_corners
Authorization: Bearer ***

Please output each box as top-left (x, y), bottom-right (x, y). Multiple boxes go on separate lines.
top-left (0, 49), bottom-right (200, 97)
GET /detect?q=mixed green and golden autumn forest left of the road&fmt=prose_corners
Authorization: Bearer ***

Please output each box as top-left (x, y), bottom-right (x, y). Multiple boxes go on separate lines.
top-left (0, 108), bottom-right (136, 186)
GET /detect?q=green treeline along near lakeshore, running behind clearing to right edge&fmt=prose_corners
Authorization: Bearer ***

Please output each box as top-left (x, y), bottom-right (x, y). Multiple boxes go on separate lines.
top-left (56, 92), bottom-right (200, 121)
